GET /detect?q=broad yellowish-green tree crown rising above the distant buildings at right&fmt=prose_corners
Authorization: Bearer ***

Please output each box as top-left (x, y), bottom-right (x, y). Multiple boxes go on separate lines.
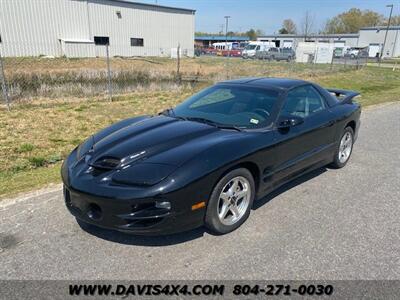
top-left (324, 8), bottom-right (384, 33)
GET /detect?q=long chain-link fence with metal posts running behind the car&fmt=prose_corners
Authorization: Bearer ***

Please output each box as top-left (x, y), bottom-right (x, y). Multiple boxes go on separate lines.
top-left (0, 40), bottom-right (376, 108)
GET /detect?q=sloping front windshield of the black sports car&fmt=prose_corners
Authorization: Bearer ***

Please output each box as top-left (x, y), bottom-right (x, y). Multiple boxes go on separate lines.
top-left (173, 85), bottom-right (279, 128)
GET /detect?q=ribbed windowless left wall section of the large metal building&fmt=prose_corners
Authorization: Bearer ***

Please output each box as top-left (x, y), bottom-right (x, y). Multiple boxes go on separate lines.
top-left (0, 0), bottom-right (89, 56)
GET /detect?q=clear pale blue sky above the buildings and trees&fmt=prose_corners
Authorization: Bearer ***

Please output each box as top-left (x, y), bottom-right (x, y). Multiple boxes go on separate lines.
top-left (137, 0), bottom-right (400, 34)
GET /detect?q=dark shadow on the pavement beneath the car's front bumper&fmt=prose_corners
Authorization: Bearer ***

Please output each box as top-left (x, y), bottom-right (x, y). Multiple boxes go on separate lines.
top-left (77, 221), bottom-right (206, 247)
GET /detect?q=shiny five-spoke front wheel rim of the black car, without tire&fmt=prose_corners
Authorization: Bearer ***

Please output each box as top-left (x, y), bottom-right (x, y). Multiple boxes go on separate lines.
top-left (217, 176), bottom-right (251, 226)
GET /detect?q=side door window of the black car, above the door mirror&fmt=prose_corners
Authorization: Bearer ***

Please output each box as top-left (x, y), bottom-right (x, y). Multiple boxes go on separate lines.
top-left (281, 85), bottom-right (325, 118)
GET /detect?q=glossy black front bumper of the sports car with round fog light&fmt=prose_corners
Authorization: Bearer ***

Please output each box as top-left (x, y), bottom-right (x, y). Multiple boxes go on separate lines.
top-left (63, 185), bottom-right (204, 235)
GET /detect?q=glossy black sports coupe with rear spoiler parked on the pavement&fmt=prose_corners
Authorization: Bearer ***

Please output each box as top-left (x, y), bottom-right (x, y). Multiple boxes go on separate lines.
top-left (62, 78), bottom-right (361, 234)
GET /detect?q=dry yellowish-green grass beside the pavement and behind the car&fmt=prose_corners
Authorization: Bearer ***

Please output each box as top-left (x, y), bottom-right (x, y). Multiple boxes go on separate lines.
top-left (0, 58), bottom-right (400, 198)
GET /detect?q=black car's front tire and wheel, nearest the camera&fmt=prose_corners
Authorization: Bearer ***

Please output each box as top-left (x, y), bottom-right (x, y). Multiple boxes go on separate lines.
top-left (205, 168), bottom-right (255, 234)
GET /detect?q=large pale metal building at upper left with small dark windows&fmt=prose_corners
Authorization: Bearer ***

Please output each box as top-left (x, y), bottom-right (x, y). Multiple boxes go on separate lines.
top-left (0, 0), bottom-right (195, 57)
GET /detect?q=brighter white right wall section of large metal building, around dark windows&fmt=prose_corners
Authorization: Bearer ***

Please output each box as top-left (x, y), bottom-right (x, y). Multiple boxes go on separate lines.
top-left (89, 0), bottom-right (194, 56)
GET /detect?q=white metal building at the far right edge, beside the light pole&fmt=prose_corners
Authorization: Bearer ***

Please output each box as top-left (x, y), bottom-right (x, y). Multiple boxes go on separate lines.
top-left (358, 26), bottom-right (400, 58)
